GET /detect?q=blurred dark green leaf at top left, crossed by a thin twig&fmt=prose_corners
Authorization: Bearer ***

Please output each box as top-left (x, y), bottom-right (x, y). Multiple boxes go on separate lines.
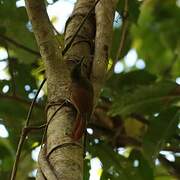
top-left (0, 0), bottom-right (38, 64)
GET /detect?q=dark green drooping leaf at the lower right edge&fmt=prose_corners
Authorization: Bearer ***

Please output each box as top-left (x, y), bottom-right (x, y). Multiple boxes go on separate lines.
top-left (142, 107), bottom-right (180, 165)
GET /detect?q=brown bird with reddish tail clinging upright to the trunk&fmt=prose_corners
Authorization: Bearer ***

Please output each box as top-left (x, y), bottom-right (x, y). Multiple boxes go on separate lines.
top-left (70, 57), bottom-right (94, 141)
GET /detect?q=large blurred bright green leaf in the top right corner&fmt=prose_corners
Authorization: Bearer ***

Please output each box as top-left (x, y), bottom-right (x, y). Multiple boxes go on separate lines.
top-left (131, 0), bottom-right (180, 78)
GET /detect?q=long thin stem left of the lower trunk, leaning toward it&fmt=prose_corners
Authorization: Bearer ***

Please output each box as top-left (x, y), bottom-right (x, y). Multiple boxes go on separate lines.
top-left (11, 79), bottom-right (46, 180)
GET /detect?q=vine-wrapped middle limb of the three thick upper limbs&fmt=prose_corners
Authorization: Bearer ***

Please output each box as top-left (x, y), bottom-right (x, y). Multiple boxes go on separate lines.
top-left (64, 0), bottom-right (96, 76)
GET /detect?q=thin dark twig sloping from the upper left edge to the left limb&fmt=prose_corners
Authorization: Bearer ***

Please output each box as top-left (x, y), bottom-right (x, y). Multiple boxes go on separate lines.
top-left (0, 34), bottom-right (41, 56)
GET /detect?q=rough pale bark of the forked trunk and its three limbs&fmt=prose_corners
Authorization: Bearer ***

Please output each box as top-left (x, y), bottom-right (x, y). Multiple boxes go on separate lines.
top-left (26, 0), bottom-right (115, 180)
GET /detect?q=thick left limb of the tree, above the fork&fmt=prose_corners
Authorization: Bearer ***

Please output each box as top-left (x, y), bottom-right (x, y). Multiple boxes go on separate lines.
top-left (25, 0), bottom-right (61, 65)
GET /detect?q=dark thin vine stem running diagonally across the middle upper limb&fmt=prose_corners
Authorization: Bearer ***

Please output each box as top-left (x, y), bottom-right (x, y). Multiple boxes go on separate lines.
top-left (62, 0), bottom-right (100, 55)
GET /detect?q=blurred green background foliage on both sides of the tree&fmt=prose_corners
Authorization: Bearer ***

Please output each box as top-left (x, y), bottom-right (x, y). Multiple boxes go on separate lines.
top-left (0, 0), bottom-right (180, 180)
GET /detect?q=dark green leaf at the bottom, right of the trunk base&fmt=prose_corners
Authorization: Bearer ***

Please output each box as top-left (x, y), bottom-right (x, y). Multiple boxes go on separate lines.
top-left (89, 142), bottom-right (152, 180)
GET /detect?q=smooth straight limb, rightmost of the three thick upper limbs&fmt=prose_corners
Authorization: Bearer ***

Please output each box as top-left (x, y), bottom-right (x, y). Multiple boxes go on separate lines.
top-left (91, 0), bottom-right (117, 104)
